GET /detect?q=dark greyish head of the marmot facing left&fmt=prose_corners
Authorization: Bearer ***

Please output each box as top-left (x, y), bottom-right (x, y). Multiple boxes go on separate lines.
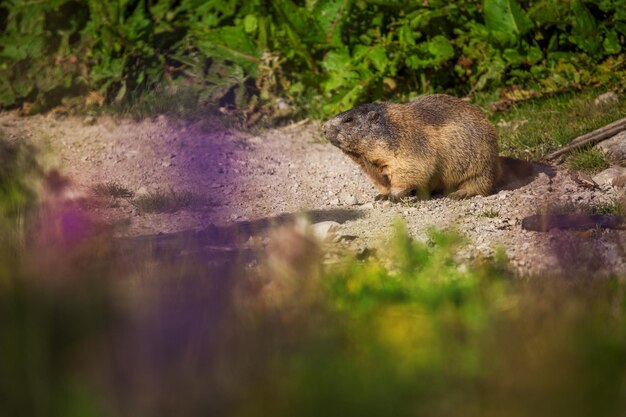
top-left (322, 103), bottom-right (391, 155)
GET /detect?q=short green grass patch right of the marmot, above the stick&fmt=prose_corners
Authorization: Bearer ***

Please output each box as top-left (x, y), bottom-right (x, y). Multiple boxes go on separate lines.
top-left (490, 90), bottom-right (626, 161)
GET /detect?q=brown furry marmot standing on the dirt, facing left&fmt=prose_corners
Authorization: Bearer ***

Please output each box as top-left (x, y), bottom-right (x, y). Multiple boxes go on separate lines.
top-left (323, 94), bottom-right (502, 201)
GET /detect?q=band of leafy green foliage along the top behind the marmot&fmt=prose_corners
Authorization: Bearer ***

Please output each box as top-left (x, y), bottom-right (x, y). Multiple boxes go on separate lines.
top-left (0, 0), bottom-right (626, 114)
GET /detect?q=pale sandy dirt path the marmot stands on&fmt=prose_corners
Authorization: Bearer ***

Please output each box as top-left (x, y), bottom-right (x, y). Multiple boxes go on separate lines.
top-left (0, 112), bottom-right (626, 274)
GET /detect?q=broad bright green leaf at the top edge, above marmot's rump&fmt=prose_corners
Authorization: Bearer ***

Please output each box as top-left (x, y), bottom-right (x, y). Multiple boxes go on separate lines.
top-left (484, 0), bottom-right (533, 38)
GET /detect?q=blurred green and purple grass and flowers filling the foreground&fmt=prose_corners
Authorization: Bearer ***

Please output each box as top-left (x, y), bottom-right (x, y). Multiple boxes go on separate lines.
top-left (0, 218), bottom-right (626, 417)
